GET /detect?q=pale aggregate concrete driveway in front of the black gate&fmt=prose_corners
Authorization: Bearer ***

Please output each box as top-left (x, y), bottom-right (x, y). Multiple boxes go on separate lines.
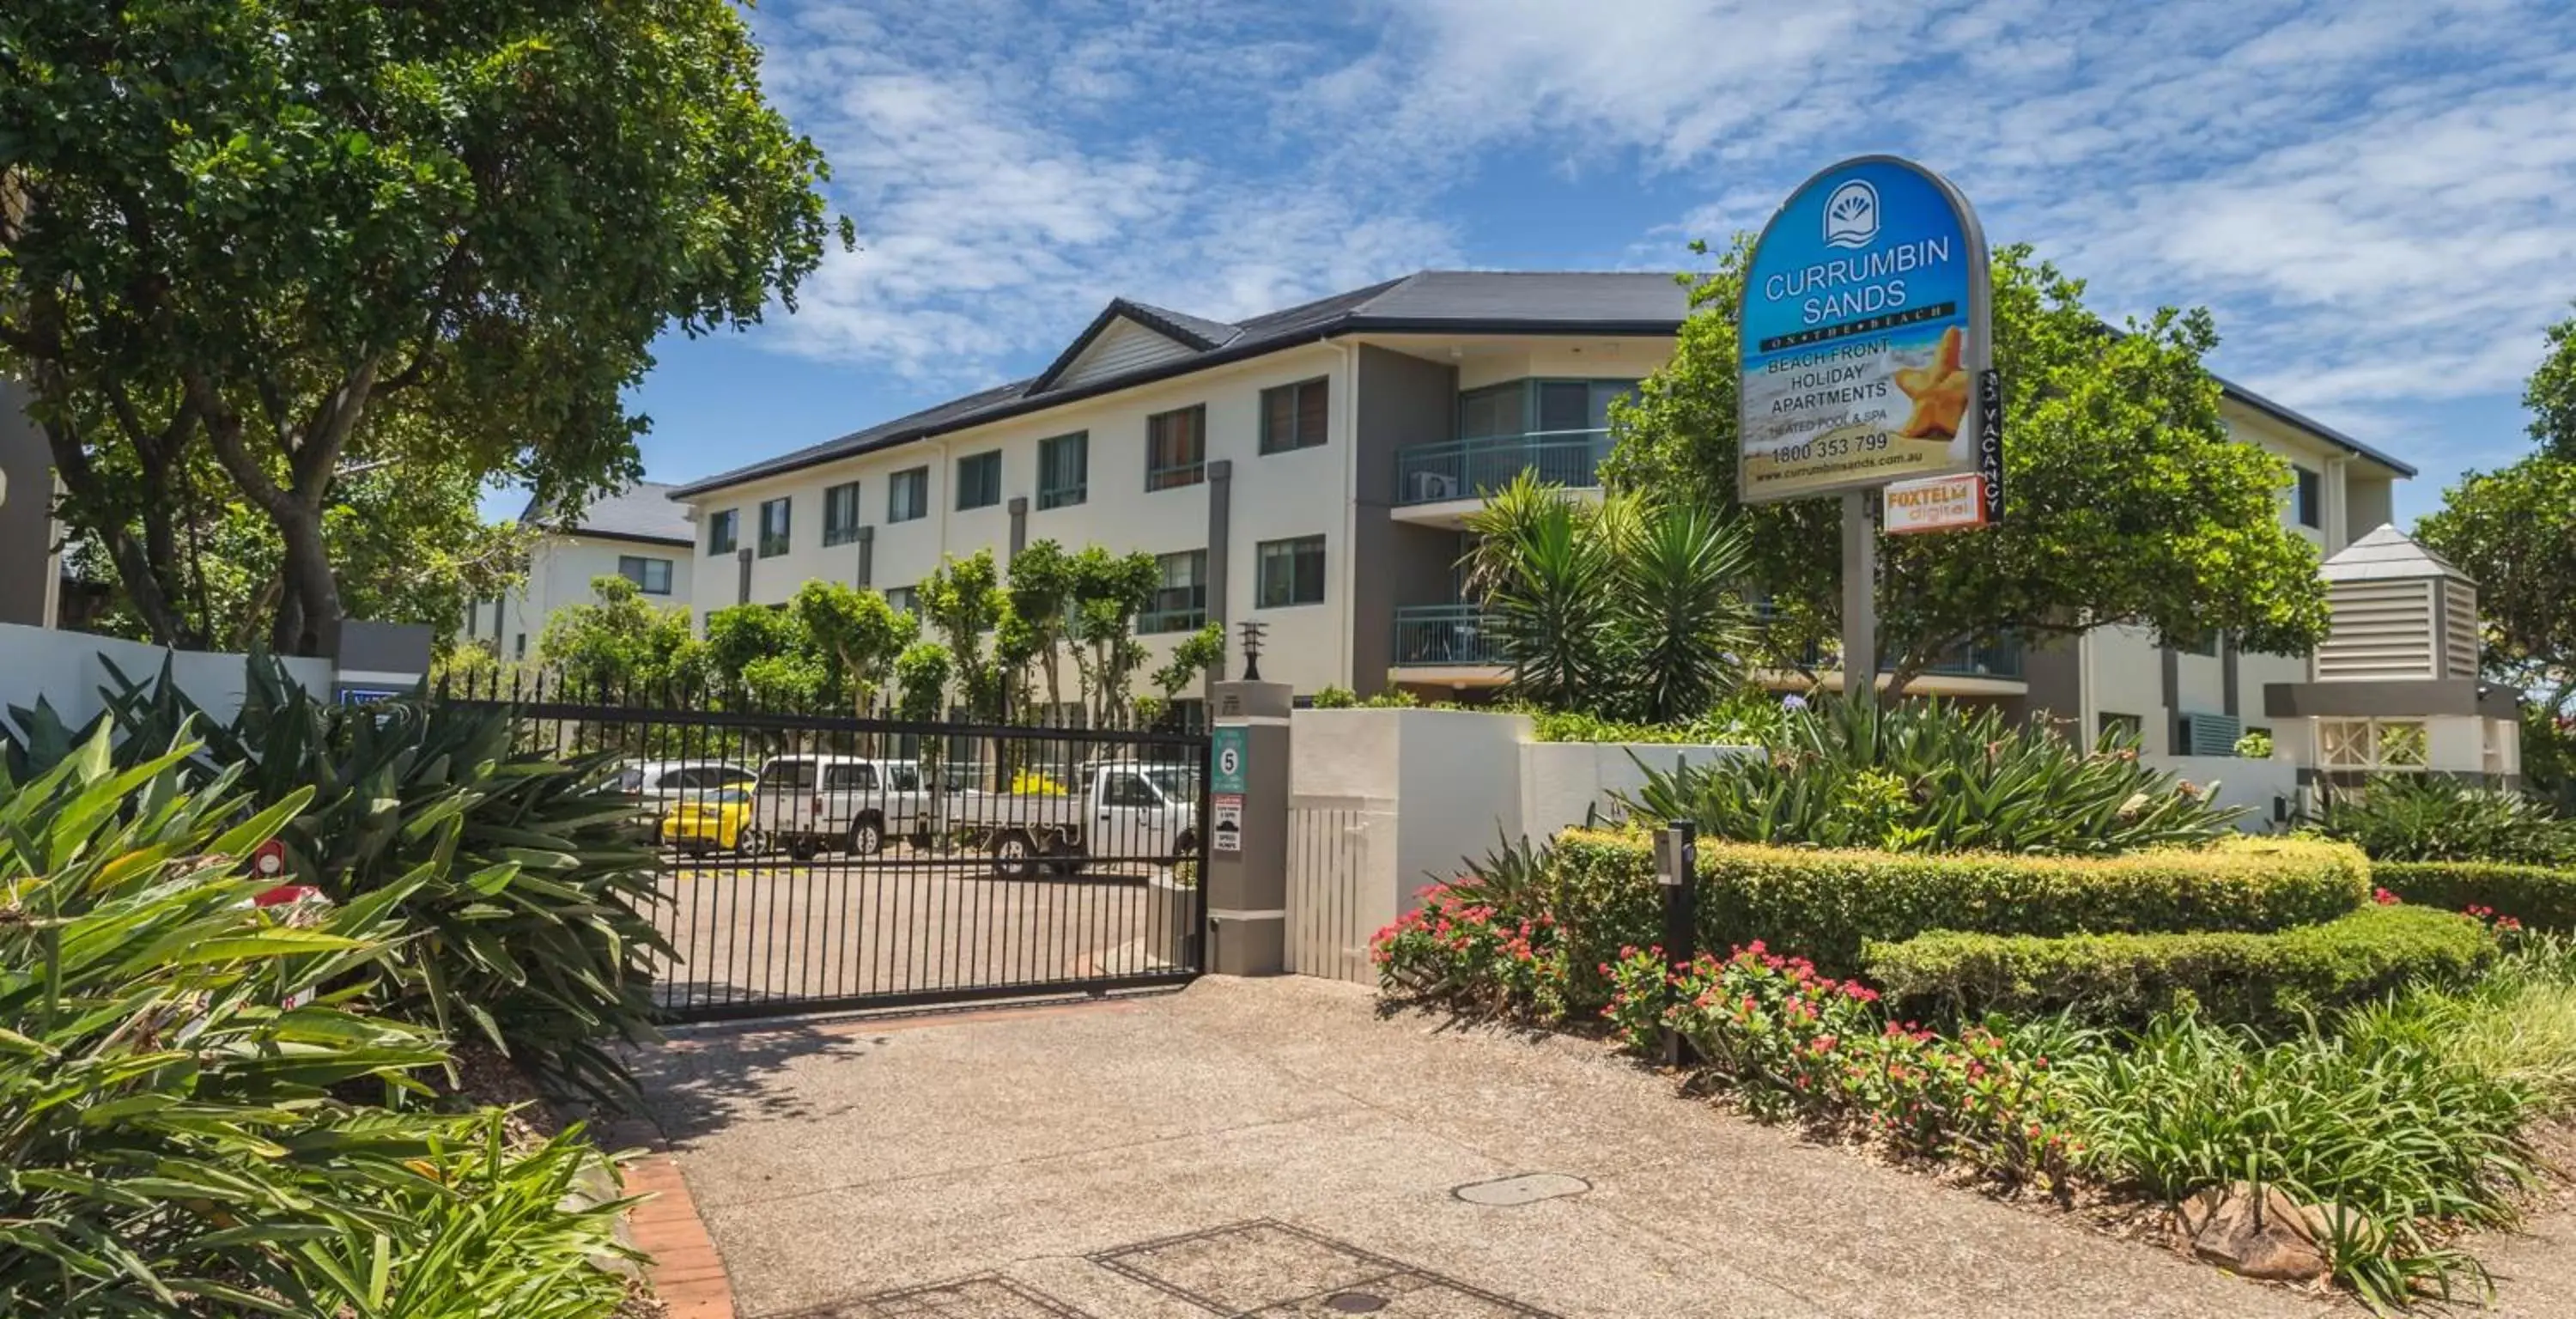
top-left (644, 979), bottom-right (2537, 1319)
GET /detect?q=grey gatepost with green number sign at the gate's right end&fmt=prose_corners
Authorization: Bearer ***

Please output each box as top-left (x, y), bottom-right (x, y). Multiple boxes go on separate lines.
top-left (1206, 683), bottom-right (1293, 976)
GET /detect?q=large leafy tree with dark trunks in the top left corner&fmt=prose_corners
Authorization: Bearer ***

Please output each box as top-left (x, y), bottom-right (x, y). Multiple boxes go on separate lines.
top-left (0, 0), bottom-right (848, 652)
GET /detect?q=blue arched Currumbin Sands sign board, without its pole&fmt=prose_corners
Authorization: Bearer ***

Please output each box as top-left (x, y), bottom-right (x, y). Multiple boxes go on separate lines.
top-left (1736, 155), bottom-right (1994, 502)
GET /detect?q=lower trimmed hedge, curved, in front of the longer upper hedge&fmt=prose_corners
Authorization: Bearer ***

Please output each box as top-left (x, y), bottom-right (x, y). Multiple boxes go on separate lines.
top-left (1865, 904), bottom-right (2496, 1025)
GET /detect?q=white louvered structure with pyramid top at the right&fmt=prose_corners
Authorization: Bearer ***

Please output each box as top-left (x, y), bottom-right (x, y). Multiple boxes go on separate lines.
top-left (2316, 526), bottom-right (2478, 683)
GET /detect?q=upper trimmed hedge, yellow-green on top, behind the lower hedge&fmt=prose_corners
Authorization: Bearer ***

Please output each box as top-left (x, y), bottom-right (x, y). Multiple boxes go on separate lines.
top-left (1548, 830), bottom-right (2370, 1000)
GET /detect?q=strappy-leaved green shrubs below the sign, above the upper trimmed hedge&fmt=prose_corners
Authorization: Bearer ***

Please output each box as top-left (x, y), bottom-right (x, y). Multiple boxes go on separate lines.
top-left (1623, 701), bottom-right (2244, 855)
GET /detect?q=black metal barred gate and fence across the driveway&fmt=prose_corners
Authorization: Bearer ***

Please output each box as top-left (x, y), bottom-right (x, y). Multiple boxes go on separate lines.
top-left (440, 675), bottom-right (1208, 1020)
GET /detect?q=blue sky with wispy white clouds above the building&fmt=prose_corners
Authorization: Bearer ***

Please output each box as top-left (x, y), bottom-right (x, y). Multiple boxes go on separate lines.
top-left (580, 0), bottom-right (2576, 520)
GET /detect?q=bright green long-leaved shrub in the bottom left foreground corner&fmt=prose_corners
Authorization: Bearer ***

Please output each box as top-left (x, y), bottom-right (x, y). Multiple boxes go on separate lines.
top-left (0, 732), bottom-right (639, 1319)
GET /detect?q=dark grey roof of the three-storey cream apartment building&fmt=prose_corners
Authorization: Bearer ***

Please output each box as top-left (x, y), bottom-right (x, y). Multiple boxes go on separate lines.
top-left (672, 270), bottom-right (2414, 500)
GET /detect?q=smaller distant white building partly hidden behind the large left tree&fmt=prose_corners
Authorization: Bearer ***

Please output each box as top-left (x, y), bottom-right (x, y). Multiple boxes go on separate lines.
top-left (459, 482), bottom-right (698, 660)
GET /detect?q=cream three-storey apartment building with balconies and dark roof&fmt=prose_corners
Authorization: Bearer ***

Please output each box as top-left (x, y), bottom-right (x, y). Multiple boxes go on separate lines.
top-left (672, 270), bottom-right (2414, 755)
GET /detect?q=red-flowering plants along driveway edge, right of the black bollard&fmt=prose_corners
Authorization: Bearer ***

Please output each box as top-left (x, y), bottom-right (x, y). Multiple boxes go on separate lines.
top-left (1602, 943), bottom-right (2079, 1185)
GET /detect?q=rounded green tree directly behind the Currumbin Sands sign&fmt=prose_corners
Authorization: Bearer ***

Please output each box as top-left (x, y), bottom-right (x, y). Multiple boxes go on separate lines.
top-left (1605, 240), bottom-right (2326, 683)
